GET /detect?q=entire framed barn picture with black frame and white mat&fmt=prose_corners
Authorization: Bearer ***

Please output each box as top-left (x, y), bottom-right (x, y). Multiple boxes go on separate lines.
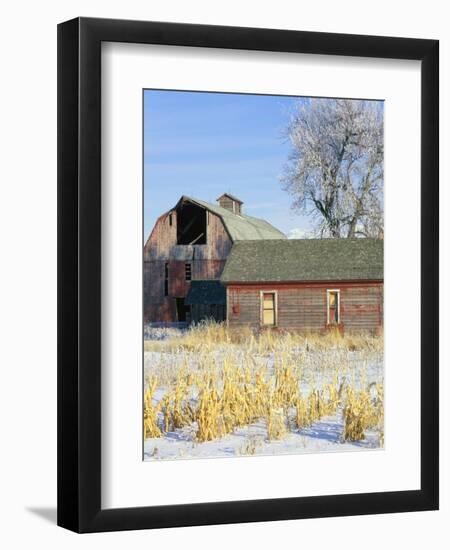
top-left (58, 18), bottom-right (439, 532)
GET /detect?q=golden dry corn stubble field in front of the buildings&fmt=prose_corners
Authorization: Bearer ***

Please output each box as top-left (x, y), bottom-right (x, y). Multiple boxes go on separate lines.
top-left (143, 322), bottom-right (384, 459)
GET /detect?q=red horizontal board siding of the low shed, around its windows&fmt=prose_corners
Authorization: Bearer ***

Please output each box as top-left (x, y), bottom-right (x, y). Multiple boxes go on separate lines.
top-left (227, 282), bottom-right (383, 331)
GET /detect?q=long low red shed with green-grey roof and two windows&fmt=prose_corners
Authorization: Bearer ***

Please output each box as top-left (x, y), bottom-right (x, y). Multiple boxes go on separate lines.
top-left (221, 239), bottom-right (383, 331)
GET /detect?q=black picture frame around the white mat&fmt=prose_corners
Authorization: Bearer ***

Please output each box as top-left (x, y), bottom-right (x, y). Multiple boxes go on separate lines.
top-left (58, 18), bottom-right (439, 532)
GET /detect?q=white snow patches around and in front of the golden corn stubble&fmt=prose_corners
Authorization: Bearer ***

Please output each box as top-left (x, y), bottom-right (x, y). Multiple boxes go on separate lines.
top-left (144, 328), bottom-right (383, 460)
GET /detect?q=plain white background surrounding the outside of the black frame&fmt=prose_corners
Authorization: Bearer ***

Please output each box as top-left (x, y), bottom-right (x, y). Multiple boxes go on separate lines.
top-left (0, 0), bottom-right (450, 550)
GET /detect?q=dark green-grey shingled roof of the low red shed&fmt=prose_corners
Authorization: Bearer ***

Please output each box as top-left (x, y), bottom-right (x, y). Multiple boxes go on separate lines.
top-left (221, 239), bottom-right (383, 283)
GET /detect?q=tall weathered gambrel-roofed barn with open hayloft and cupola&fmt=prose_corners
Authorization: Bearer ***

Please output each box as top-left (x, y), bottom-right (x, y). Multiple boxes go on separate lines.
top-left (143, 193), bottom-right (286, 324)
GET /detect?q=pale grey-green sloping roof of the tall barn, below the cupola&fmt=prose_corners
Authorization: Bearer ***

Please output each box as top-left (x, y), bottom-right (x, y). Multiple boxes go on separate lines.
top-left (181, 196), bottom-right (286, 241)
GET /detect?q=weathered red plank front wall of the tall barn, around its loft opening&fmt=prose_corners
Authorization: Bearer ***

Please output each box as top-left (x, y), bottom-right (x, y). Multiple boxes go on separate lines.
top-left (143, 210), bottom-right (232, 322)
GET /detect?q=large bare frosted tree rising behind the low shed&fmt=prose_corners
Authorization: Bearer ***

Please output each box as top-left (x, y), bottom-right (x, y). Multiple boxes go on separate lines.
top-left (282, 99), bottom-right (384, 237)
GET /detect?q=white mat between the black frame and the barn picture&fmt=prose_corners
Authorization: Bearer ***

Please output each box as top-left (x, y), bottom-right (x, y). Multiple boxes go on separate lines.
top-left (102, 43), bottom-right (420, 508)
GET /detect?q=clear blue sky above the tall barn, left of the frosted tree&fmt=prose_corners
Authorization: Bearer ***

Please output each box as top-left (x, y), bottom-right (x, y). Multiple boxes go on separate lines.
top-left (144, 90), bottom-right (310, 238)
